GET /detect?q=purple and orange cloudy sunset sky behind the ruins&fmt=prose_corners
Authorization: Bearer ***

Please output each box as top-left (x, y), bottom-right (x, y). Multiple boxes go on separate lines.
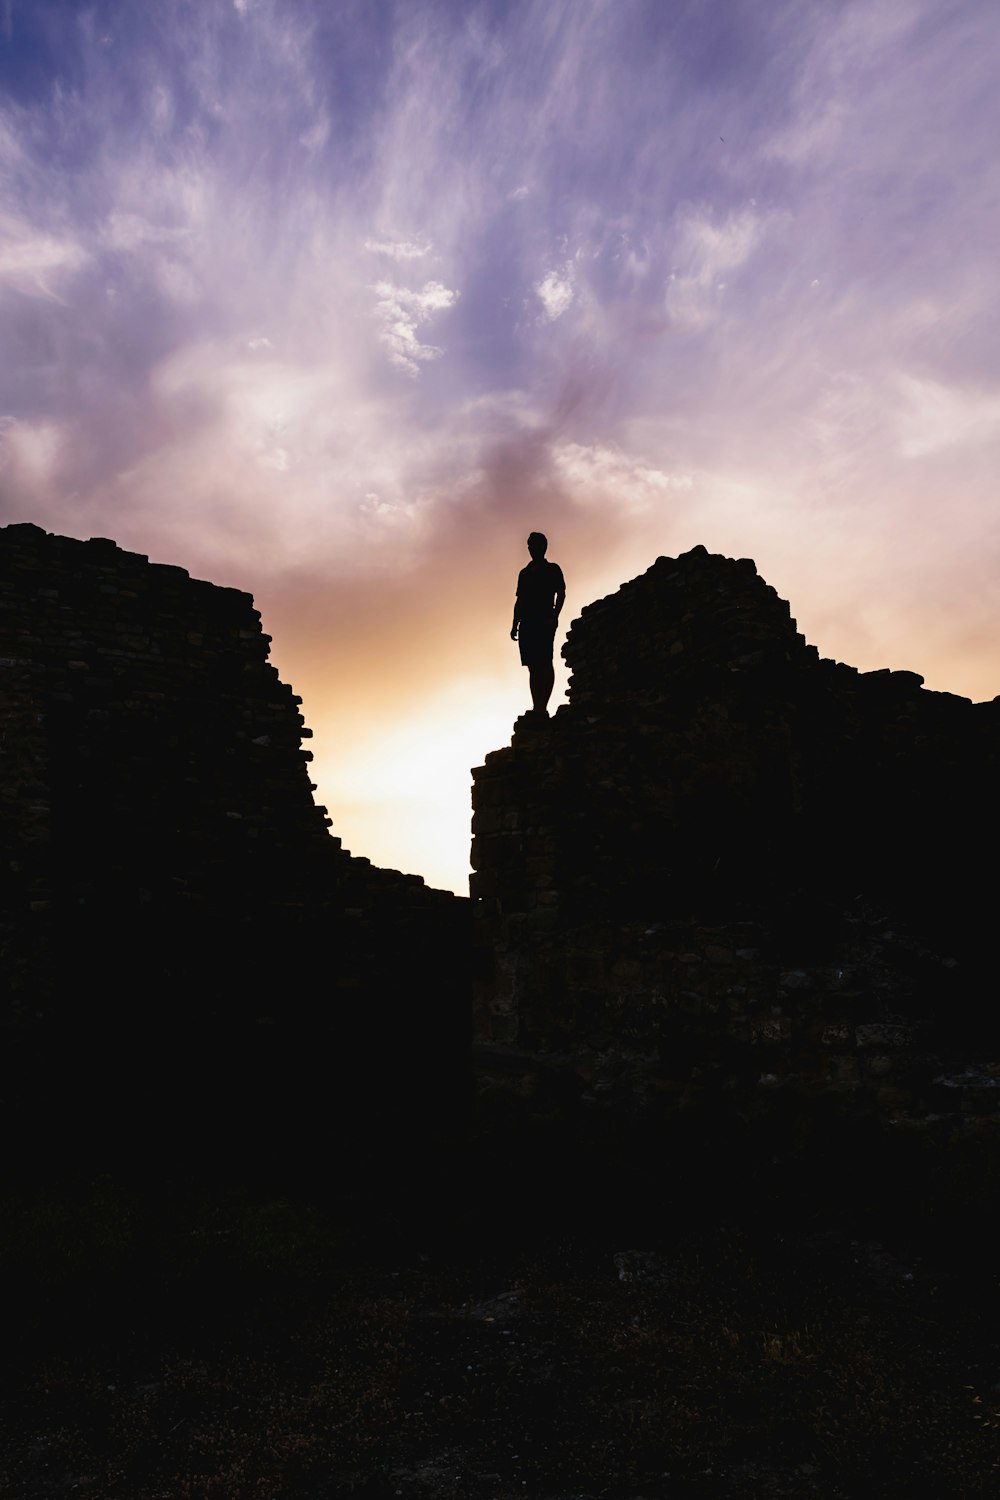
top-left (0, 0), bottom-right (1000, 891)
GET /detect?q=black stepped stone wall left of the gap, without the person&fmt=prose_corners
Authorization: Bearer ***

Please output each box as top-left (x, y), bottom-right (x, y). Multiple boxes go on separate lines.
top-left (0, 525), bottom-right (468, 1179)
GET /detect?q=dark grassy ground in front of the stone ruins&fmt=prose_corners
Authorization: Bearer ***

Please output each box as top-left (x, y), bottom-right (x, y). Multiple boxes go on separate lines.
top-left (0, 1181), bottom-right (1000, 1500)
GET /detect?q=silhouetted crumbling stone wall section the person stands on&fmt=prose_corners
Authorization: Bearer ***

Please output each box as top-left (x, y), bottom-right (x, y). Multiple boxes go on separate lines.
top-left (472, 548), bottom-right (1000, 1224)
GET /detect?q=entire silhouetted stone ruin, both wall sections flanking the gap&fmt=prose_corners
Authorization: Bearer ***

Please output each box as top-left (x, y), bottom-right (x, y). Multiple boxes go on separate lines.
top-left (0, 527), bottom-right (1000, 1230)
